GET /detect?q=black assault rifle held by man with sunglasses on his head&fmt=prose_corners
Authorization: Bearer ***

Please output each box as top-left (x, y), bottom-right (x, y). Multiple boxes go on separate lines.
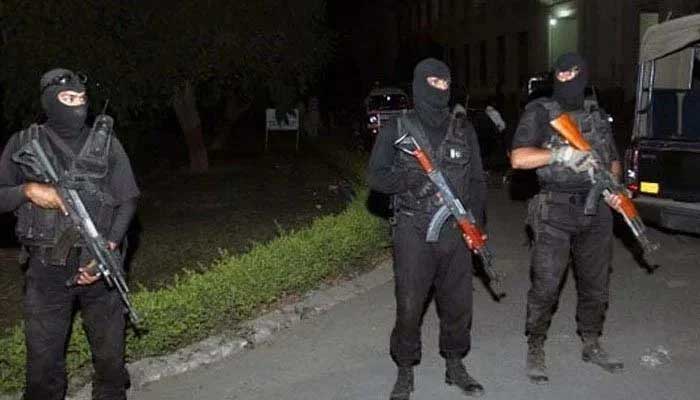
top-left (17, 114), bottom-right (140, 329)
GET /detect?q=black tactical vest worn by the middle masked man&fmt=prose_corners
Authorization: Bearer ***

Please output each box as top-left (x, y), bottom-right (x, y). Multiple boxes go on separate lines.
top-left (393, 112), bottom-right (476, 215)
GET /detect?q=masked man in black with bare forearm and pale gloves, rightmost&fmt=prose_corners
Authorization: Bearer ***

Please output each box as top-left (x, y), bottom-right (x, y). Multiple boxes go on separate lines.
top-left (511, 53), bottom-right (623, 383)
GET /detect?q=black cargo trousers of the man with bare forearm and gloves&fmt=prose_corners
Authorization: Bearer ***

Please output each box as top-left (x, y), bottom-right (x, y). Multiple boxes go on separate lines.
top-left (525, 192), bottom-right (613, 336)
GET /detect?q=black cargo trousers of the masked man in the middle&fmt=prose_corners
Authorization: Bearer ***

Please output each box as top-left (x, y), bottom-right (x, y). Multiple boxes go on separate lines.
top-left (390, 213), bottom-right (472, 366)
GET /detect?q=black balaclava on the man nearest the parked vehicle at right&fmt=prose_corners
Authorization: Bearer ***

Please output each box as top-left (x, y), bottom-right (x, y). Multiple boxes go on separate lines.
top-left (552, 53), bottom-right (588, 111)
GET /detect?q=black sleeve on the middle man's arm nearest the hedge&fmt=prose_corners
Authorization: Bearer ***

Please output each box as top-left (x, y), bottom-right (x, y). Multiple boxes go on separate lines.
top-left (367, 120), bottom-right (416, 194)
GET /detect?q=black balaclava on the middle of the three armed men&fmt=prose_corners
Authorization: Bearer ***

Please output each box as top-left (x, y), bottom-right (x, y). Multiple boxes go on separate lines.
top-left (413, 58), bottom-right (450, 128)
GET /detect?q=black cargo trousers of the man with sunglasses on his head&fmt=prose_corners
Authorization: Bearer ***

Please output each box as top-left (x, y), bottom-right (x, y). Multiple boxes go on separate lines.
top-left (24, 250), bottom-right (128, 400)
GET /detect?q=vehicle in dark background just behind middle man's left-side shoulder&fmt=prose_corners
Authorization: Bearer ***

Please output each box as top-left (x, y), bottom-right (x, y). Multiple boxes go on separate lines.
top-left (363, 87), bottom-right (411, 148)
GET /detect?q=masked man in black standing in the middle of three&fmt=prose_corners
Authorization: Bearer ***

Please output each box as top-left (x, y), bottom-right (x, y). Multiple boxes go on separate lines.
top-left (368, 59), bottom-right (486, 399)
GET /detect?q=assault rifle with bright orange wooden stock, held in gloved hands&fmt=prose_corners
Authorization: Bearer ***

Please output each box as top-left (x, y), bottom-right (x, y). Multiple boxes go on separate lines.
top-left (549, 113), bottom-right (659, 254)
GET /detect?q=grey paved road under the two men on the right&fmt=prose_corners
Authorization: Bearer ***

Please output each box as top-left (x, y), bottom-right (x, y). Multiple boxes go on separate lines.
top-left (130, 190), bottom-right (700, 400)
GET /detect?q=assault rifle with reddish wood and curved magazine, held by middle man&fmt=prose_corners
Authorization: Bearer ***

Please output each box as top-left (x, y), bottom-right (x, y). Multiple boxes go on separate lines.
top-left (394, 128), bottom-right (506, 301)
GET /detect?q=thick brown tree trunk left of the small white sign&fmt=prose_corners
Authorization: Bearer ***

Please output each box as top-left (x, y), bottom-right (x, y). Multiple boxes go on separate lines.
top-left (173, 81), bottom-right (209, 172)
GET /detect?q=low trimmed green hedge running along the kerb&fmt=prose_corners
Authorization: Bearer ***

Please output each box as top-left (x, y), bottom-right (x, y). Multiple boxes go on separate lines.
top-left (0, 141), bottom-right (388, 393)
